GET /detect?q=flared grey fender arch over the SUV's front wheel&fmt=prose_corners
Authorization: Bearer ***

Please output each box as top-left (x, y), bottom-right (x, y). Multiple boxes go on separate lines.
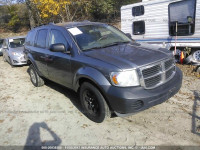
top-left (73, 67), bottom-right (111, 92)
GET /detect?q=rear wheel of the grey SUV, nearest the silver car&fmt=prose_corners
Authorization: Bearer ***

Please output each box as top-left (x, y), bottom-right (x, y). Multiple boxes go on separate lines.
top-left (28, 65), bottom-right (44, 87)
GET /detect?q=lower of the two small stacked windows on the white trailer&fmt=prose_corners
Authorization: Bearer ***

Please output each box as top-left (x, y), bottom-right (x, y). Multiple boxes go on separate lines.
top-left (133, 21), bottom-right (145, 35)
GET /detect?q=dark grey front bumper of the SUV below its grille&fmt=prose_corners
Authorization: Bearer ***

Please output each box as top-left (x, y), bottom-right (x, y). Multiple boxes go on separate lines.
top-left (103, 67), bottom-right (182, 117)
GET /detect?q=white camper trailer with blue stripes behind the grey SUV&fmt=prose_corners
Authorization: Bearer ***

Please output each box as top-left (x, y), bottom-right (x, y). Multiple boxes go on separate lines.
top-left (121, 0), bottom-right (200, 61)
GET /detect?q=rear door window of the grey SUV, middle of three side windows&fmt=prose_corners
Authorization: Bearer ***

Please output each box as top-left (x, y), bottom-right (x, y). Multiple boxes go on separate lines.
top-left (35, 29), bottom-right (48, 48)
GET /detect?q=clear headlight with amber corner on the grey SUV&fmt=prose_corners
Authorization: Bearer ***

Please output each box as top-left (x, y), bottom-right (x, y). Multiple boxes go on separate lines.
top-left (110, 70), bottom-right (140, 87)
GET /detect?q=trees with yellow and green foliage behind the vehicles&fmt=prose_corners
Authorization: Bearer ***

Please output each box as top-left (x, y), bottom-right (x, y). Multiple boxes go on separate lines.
top-left (0, 0), bottom-right (141, 32)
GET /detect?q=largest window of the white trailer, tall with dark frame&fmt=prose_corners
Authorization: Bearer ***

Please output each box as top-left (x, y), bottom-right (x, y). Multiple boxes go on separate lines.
top-left (169, 0), bottom-right (196, 36)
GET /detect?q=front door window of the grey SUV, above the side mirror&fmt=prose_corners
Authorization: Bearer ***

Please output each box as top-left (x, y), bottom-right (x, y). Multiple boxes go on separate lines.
top-left (49, 29), bottom-right (68, 47)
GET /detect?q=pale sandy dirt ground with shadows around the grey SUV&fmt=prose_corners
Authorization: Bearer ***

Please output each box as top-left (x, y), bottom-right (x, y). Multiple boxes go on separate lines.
top-left (0, 57), bottom-right (200, 146)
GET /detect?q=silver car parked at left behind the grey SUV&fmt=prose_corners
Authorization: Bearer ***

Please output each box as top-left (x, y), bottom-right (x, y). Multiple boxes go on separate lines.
top-left (3, 36), bottom-right (27, 67)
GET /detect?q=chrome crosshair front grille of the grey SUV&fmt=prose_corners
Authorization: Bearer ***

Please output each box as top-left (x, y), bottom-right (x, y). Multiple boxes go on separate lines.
top-left (141, 59), bottom-right (175, 89)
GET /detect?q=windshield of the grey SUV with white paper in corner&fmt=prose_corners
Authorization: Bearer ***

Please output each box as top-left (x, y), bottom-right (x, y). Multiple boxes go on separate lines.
top-left (68, 25), bottom-right (132, 51)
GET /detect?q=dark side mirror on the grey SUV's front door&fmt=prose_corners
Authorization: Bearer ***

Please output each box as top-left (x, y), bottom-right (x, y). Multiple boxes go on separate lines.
top-left (50, 43), bottom-right (70, 54)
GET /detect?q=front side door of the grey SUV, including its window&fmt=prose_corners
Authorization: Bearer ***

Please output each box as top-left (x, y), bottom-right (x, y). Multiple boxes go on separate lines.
top-left (47, 29), bottom-right (72, 87)
